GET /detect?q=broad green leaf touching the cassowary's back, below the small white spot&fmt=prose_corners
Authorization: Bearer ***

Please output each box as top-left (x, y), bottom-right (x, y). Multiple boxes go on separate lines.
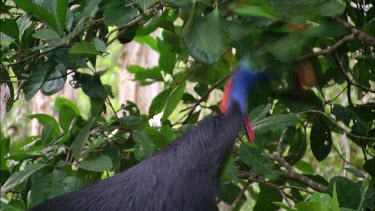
top-left (132, 131), bottom-right (157, 161)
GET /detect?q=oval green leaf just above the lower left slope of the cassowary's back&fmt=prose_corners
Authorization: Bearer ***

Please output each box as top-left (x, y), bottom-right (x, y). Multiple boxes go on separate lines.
top-left (78, 155), bottom-right (113, 172)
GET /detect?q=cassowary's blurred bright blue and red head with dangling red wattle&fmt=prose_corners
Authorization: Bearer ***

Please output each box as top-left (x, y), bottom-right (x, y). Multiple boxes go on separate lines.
top-left (220, 61), bottom-right (267, 141)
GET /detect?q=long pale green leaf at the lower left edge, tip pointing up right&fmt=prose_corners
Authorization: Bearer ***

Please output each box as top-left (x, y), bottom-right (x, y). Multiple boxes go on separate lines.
top-left (1, 163), bottom-right (48, 193)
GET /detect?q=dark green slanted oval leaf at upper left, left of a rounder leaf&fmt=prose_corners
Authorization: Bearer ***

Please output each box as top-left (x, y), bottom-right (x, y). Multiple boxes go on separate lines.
top-left (23, 62), bottom-right (56, 100)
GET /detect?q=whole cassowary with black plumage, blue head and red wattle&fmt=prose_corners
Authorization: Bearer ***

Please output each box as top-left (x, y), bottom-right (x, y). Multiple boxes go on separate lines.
top-left (31, 63), bottom-right (263, 211)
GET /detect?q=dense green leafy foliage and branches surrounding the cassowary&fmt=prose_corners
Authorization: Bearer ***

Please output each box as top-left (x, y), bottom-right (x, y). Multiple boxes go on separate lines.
top-left (0, 0), bottom-right (375, 210)
